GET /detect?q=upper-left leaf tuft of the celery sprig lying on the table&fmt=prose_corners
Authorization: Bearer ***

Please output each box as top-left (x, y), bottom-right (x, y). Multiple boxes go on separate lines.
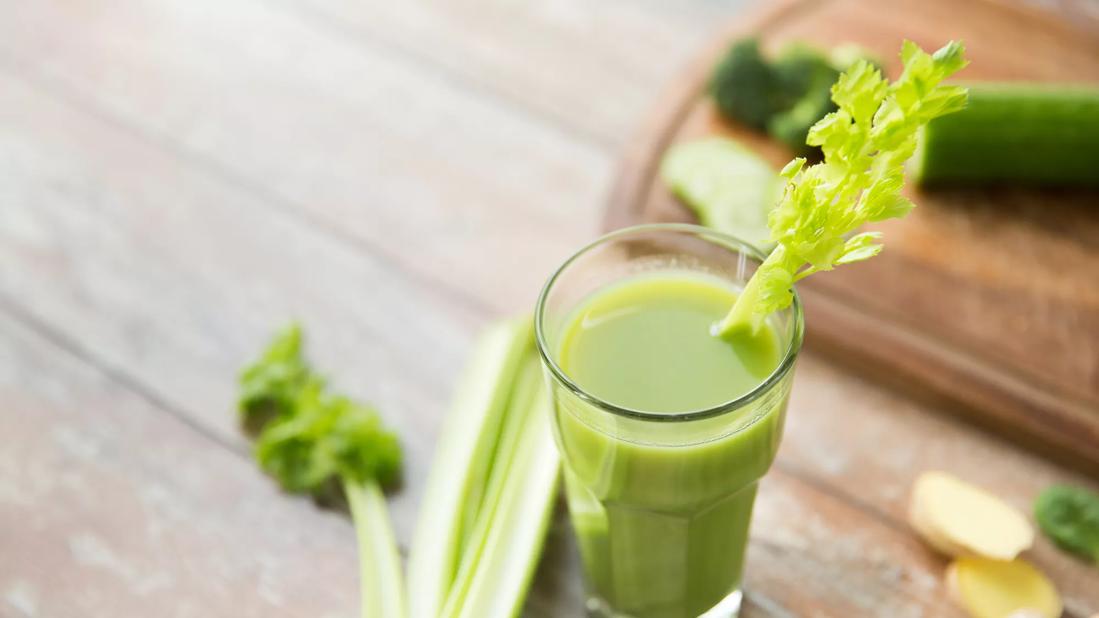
top-left (237, 322), bottom-right (310, 433)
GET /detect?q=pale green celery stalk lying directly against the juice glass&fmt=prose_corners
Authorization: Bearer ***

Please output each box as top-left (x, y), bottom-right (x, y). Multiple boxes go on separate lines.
top-left (441, 352), bottom-right (559, 618)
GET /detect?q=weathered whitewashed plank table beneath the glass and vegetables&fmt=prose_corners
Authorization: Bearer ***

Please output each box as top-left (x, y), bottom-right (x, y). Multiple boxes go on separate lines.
top-left (0, 0), bottom-right (1099, 618)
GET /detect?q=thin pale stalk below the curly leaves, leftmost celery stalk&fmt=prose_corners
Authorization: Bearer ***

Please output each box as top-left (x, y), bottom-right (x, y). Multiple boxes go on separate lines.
top-left (343, 479), bottom-right (408, 618)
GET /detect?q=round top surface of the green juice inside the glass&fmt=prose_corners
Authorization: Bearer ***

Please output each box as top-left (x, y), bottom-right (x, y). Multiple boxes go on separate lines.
top-left (558, 273), bottom-right (778, 412)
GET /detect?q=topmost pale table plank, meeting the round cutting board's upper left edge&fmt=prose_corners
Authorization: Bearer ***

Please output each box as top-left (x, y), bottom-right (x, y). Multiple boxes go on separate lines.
top-left (288, 0), bottom-right (725, 147)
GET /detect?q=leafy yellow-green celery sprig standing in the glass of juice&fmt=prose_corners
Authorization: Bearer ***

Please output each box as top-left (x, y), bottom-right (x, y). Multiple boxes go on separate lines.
top-left (714, 41), bottom-right (966, 338)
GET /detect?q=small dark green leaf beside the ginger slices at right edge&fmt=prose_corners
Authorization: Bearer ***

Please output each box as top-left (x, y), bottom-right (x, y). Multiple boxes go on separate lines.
top-left (1034, 485), bottom-right (1099, 564)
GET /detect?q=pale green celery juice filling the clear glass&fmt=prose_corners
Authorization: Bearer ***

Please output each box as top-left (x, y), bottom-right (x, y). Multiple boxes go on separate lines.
top-left (554, 271), bottom-right (789, 618)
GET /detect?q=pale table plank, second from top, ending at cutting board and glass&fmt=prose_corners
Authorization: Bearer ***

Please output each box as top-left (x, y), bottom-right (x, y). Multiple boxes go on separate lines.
top-left (0, 0), bottom-right (611, 311)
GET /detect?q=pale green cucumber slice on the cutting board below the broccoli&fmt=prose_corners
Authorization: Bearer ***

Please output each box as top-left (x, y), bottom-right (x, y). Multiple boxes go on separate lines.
top-left (660, 137), bottom-right (782, 252)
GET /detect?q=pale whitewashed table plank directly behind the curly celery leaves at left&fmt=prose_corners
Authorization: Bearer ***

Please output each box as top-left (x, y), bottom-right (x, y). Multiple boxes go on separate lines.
top-left (0, 70), bottom-right (472, 539)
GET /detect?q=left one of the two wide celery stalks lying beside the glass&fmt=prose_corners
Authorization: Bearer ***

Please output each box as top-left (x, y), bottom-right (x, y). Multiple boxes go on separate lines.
top-left (408, 318), bottom-right (533, 618)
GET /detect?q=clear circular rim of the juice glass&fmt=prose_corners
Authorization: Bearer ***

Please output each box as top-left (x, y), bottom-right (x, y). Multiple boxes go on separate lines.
top-left (534, 223), bottom-right (804, 422)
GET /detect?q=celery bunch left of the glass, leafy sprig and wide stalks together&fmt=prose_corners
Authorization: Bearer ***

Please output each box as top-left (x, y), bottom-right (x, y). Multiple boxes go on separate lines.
top-left (238, 319), bottom-right (558, 618)
